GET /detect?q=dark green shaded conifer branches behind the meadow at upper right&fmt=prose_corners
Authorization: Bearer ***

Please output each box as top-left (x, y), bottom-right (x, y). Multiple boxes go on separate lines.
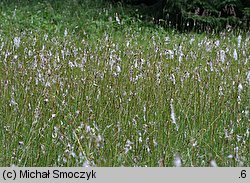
top-left (112, 0), bottom-right (250, 30)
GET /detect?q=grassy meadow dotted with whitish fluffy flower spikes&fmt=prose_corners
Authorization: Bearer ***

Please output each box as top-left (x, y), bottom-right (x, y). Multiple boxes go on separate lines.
top-left (0, 0), bottom-right (250, 167)
